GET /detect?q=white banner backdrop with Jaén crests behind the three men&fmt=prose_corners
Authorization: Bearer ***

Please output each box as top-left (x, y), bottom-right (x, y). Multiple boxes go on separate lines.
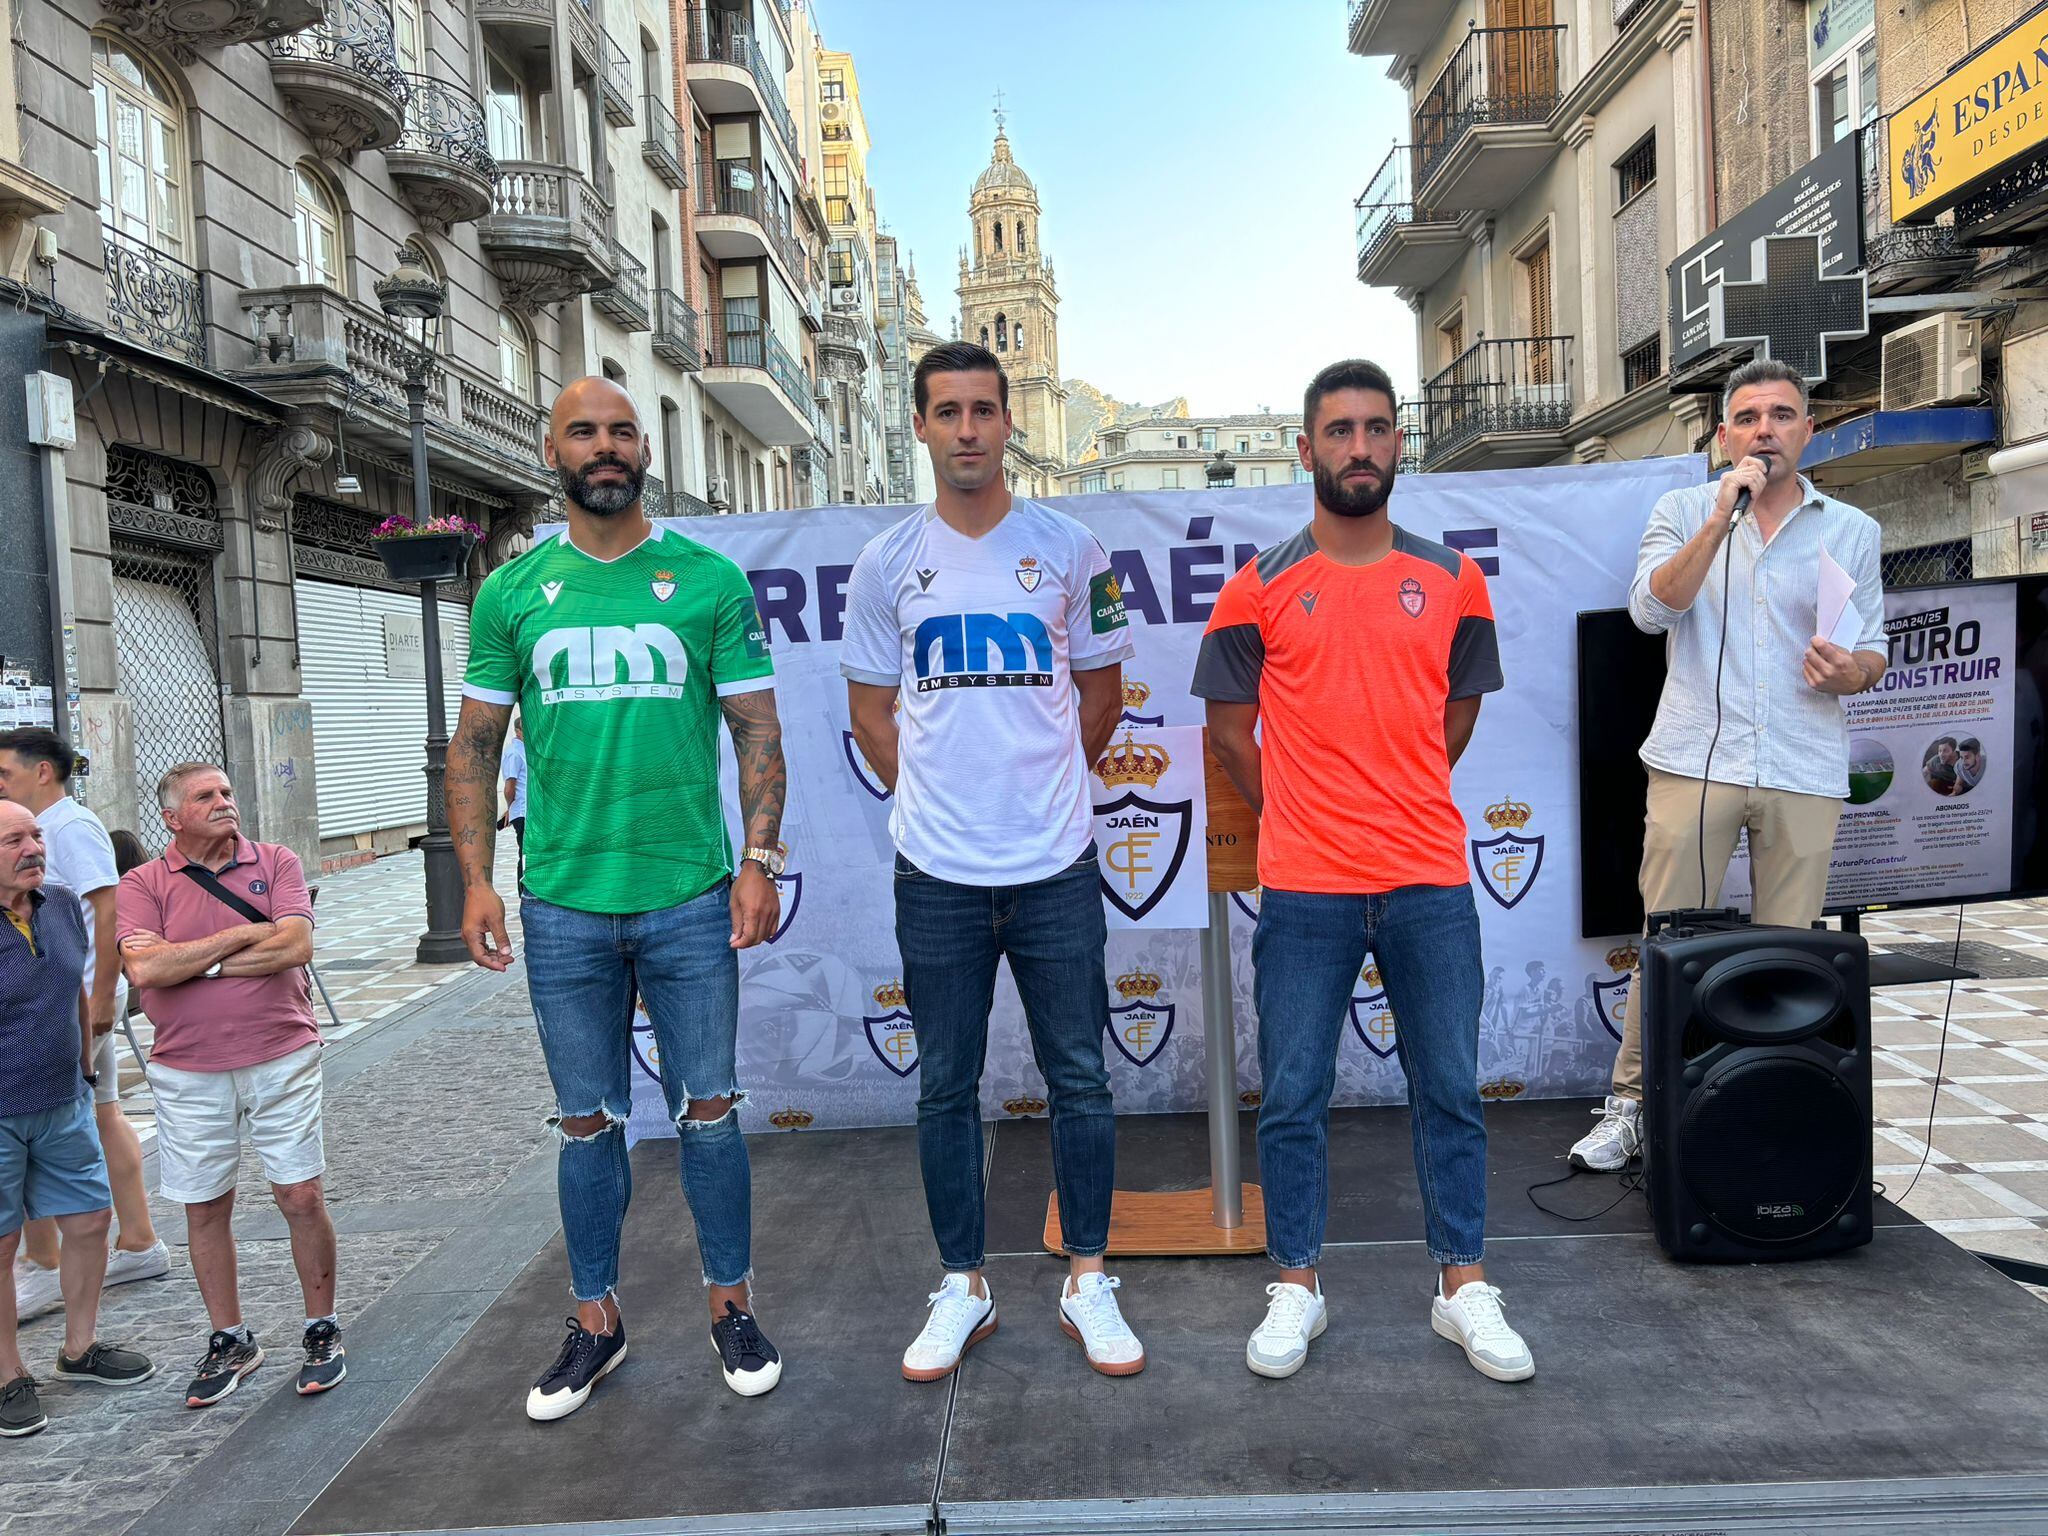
top-left (614, 457), bottom-right (1706, 1137)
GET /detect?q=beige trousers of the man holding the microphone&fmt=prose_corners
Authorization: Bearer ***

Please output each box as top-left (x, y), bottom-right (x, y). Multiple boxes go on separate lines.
top-left (1614, 768), bottom-right (1841, 1102)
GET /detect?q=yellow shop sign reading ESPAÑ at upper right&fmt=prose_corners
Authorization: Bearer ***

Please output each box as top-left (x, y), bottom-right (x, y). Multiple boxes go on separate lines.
top-left (1886, 4), bottom-right (2048, 223)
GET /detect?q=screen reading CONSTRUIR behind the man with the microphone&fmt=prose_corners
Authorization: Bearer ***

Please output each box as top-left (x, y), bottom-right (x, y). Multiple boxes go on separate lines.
top-left (1722, 584), bottom-right (2017, 907)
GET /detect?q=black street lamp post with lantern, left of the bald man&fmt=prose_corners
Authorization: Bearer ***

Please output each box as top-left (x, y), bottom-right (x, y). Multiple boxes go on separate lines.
top-left (377, 246), bottom-right (469, 965)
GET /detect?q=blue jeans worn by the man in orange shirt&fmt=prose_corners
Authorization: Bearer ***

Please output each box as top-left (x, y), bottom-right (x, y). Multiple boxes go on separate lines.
top-left (1251, 885), bottom-right (1487, 1270)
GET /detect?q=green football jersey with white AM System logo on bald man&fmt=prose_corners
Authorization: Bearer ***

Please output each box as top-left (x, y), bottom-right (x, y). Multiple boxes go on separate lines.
top-left (463, 526), bottom-right (774, 913)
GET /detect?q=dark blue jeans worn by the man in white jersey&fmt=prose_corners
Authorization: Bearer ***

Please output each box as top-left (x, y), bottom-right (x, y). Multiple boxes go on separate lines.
top-left (895, 846), bottom-right (1116, 1270)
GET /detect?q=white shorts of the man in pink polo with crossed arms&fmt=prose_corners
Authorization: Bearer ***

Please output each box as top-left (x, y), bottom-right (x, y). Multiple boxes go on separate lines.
top-left (150, 1040), bottom-right (328, 1204)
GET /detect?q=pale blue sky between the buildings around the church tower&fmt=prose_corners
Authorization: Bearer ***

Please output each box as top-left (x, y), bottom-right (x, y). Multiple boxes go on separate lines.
top-left (815, 0), bottom-right (1415, 414)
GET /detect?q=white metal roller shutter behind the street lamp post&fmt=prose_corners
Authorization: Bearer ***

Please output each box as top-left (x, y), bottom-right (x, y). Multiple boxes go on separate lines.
top-left (293, 578), bottom-right (469, 838)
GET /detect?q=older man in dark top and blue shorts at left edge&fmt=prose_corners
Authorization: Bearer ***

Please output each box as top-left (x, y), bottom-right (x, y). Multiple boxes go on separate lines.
top-left (0, 801), bottom-right (156, 1436)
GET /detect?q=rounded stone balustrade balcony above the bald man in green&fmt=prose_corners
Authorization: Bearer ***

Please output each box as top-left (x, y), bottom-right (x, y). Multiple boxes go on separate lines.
top-left (477, 160), bottom-right (618, 307)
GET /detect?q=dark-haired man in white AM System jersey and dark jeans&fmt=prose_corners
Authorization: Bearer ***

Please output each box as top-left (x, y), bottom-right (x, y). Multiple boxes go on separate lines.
top-left (840, 342), bottom-right (1145, 1380)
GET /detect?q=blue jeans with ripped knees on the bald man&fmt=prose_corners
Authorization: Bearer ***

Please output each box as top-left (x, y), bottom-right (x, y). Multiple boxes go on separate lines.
top-left (520, 881), bottom-right (754, 1300)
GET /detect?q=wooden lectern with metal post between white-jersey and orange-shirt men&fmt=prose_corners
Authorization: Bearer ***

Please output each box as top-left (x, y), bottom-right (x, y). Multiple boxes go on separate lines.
top-left (1044, 731), bottom-right (1266, 1257)
